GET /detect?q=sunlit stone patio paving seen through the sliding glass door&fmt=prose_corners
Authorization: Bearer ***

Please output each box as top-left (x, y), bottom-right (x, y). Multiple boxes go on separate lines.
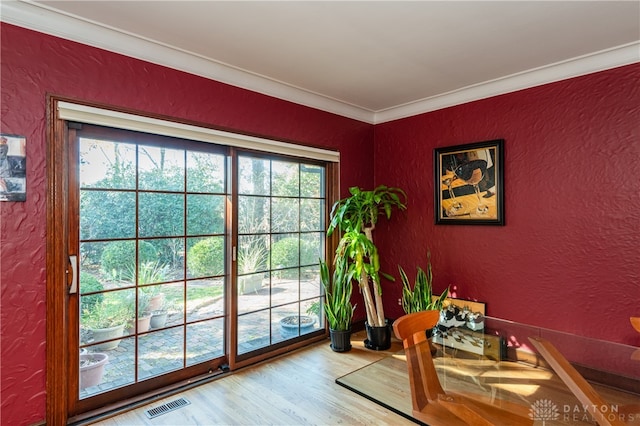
top-left (80, 281), bottom-right (324, 399)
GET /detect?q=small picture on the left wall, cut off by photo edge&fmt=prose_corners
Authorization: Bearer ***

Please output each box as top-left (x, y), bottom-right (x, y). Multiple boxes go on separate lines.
top-left (0, 134), bottom-right (27, 201)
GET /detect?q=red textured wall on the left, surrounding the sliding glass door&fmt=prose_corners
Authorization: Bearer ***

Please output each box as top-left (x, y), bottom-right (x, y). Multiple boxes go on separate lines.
top-left (0, 23), bottom-right (373, 425)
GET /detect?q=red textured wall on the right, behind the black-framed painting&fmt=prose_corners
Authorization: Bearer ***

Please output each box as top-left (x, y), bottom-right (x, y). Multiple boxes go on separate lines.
top-left (374, 64), bottom-right (640, 346)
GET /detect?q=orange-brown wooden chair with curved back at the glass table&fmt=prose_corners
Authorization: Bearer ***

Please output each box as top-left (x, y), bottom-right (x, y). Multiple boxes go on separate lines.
top-left (393, 311), bottom-right (533, 426)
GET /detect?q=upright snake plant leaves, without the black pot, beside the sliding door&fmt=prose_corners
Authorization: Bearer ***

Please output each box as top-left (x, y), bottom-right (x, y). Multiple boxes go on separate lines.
top-left (320, 259), bottom-right (356, 331)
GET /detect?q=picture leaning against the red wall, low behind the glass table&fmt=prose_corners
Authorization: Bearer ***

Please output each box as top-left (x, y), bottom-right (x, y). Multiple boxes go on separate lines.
top-left (432, 298), bottom-right (504, 360)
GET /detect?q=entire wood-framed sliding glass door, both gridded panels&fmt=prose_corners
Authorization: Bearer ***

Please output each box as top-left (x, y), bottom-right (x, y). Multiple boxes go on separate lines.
top-left (68, 123), bottom-right (327, 413)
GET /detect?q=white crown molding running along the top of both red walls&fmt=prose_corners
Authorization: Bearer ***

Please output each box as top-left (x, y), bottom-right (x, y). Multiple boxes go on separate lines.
top-left (0, 1), bottom-right (640, 124)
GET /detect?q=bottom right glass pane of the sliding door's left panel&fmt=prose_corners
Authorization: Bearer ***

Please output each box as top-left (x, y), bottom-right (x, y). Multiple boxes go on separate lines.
top-left (187, 318), bottom-right (224, 365)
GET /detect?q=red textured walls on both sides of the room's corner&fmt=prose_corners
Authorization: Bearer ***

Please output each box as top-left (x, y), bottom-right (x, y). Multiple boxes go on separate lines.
top-left (0, 20), bottom-right (640, 425)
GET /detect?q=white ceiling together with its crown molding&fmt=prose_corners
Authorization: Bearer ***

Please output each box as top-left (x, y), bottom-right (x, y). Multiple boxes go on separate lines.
top-left (2, 0), bottom-right (640, 123)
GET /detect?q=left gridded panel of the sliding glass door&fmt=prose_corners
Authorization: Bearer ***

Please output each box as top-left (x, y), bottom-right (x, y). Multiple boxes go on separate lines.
top-left (71, 126), bottom-right (229, 410)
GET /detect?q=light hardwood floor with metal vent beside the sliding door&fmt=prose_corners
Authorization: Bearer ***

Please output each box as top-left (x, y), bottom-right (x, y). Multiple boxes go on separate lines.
top-left (89, 332), bottom-right (415, 426)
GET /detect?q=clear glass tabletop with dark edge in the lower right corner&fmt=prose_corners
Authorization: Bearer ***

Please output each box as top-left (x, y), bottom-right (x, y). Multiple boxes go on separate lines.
top-left (336, 317), bottom-right (640, 425)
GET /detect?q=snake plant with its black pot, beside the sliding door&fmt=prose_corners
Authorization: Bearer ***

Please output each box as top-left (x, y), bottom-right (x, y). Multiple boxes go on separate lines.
top-left (320, 258), bottom-right (355, 352)
